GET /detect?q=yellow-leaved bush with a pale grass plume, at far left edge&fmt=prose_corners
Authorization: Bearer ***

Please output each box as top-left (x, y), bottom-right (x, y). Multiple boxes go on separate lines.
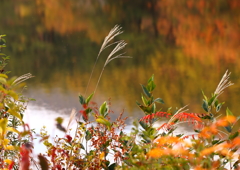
top-left (0, 35), bottom-right (32, 169)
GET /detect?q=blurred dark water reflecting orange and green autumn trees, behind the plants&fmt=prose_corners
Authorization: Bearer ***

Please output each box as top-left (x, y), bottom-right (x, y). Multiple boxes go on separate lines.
top-left (0, 0), bottom-right (240, 127)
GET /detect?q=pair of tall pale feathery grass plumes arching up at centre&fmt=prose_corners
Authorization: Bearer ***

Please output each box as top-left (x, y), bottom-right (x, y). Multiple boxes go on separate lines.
top-left (84, 25), bottom-right (130, 95)
